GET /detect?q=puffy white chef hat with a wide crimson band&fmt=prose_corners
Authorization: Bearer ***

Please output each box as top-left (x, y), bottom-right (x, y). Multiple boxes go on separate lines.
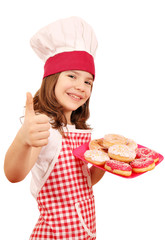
top-left (30, 17), bottom-right (97, 77)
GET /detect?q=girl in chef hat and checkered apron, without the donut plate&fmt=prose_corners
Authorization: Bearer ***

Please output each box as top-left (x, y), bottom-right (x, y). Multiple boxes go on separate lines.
top-left (4, 17), bottom-right (104, 240)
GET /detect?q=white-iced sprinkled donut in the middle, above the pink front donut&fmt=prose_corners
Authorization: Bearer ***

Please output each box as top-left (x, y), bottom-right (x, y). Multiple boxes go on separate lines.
top-left (108, 144), bottom-right (136, 162)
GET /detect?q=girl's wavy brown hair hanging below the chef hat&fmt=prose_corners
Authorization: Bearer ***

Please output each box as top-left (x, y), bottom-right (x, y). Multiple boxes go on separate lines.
top-left (33, 73), bottom-right (91, 135)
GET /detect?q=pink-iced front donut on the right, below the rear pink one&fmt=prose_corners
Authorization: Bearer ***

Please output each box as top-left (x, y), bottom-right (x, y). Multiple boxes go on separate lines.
top-left (130, 157), bottom-right (155, 173)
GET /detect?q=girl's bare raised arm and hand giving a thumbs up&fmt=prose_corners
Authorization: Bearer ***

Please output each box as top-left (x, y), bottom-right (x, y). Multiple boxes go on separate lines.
top-left (4, 93), bottom-right (50, 182)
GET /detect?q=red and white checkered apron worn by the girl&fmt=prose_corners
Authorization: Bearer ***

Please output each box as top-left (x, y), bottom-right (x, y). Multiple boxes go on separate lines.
top-left (30, 130), bottom-right (96, 240)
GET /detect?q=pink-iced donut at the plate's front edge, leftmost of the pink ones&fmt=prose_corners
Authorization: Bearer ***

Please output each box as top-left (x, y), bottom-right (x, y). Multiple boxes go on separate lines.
top-left (104, 159), bottom-right (132, 177)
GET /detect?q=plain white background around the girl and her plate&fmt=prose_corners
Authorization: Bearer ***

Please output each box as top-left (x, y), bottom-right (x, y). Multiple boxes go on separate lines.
top-left (0, 0), bottom-right (165, 240)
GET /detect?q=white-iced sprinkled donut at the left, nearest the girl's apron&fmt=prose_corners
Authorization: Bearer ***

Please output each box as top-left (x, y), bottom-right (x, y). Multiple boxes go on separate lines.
top-left (84, 149), bottom-right (109, 166)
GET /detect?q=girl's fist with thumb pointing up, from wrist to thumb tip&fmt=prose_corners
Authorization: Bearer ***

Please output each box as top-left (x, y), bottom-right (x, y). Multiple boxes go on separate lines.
top-left (22, 93), bottom-right (50, 147)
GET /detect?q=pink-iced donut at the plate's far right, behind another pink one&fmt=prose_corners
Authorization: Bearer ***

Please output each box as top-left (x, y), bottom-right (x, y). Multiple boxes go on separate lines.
top-left (136, 147), bottom-right (159, 163)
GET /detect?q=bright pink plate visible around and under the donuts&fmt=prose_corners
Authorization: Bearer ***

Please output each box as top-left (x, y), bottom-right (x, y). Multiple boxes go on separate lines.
top-left (73, 143), bottom-right (164, 178)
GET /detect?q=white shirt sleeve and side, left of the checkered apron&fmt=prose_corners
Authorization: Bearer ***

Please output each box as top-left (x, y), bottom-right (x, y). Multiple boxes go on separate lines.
top-left (30, 128), bottom-right (62, 198)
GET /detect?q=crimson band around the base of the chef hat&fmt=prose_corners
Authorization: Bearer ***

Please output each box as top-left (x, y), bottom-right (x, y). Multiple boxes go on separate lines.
top-left (44, 51), bottom-right (95, 78)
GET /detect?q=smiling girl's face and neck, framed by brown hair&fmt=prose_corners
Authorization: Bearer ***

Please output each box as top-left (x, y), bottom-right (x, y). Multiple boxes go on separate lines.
top-left (55, 70), bottom-right (93, 123)
